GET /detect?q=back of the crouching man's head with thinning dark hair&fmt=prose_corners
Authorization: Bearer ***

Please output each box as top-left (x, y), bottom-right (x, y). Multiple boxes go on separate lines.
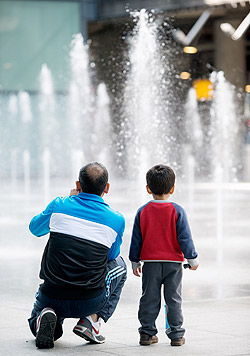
top-left (79, 162), bottom-right (108, 195)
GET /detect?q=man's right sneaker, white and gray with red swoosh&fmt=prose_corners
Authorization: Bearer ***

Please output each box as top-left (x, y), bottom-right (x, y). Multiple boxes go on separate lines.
top-left (73, 316), bottom-right (105, 344)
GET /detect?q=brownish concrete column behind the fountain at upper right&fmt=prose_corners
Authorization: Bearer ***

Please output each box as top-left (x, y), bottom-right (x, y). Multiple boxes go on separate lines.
top-left (214, 19), bottom-right (246, 88)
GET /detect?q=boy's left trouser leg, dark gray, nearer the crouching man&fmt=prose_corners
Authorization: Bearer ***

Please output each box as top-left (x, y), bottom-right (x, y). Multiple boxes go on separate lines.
top-left (138, 262), bottom-right (162, 336)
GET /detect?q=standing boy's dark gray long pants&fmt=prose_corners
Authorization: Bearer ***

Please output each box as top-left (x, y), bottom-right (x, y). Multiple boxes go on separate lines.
top-left (138, 262), bottom-right (185, 339)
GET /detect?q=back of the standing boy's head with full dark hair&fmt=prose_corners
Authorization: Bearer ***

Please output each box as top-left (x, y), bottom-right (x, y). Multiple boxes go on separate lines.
top-left (146, 164), bottom-right (175, 195)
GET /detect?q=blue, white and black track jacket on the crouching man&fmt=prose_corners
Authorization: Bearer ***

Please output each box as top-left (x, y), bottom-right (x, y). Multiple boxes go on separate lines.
top-left (29, 193), bottom-right (125, 299)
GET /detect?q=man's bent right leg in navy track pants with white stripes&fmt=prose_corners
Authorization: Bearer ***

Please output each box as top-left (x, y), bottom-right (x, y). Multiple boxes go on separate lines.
top-left (97, 256), bottom-right (127, 323)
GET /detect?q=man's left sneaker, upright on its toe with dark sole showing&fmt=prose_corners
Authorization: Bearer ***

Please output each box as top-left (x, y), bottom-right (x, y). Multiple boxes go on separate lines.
top-left (36, 308), bottom-right (57, 349)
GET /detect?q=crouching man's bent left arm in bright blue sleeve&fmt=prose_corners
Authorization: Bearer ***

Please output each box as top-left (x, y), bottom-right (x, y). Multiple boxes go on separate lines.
top-left (29, 200), bottom-right (54, 237)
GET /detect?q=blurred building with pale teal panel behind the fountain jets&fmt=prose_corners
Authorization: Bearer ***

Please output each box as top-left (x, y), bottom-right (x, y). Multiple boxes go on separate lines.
top-left (0, 0), bottom-right (250, 179)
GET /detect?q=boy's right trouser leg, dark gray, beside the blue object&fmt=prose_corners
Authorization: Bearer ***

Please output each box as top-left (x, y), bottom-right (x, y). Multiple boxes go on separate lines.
top-left (163, 262), bottom-right (185, 340)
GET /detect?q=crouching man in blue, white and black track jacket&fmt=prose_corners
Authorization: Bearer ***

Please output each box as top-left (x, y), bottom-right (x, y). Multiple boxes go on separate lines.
top-left (28, 162), bottom-right (127, 348)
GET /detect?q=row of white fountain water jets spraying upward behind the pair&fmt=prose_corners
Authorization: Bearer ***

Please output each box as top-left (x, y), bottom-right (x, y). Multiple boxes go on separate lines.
top-left (0, 10), bottom-right (242, 185)
